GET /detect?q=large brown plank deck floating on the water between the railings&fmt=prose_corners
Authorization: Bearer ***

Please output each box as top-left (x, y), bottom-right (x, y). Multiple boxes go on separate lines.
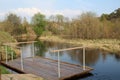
top-left (2, 57), bottom-right (93, 80)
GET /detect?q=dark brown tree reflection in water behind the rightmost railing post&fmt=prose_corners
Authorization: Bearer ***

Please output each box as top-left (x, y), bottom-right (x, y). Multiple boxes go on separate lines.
top-left (69, 49), bottom-right (99, 66)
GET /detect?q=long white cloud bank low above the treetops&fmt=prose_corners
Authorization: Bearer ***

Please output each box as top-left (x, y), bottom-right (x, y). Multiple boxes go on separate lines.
top-left (0, 8), bottom-right (82, 20)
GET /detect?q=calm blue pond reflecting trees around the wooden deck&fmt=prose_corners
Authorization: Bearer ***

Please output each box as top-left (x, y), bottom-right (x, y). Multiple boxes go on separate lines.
top-left (19, 41), bottom-right (120, 80)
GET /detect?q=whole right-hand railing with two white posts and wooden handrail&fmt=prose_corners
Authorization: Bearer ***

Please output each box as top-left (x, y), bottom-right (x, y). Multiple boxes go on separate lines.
top-left (51, 46), bottom-right (85, 78)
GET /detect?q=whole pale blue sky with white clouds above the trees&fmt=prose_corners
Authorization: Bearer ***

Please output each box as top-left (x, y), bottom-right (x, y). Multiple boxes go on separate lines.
top-left (0, 0), bottom-right (120, 20)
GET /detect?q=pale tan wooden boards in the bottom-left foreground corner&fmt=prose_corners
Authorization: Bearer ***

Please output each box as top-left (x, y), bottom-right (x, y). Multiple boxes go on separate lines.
top-left (1, 74), bottom-right (45, 80)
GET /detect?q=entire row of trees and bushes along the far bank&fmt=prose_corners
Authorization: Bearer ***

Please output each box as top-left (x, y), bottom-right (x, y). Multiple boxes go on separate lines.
top-left (0, 8), bottom-right (120, 39)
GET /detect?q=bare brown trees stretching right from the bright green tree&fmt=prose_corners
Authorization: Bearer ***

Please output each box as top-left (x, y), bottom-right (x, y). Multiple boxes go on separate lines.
top-left (47, 8), bottom-right (120, 39)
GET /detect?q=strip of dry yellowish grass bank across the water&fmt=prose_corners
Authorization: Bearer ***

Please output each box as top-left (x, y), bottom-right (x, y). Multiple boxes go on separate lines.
top-left (39, 36), bottom-right (120, 53)
